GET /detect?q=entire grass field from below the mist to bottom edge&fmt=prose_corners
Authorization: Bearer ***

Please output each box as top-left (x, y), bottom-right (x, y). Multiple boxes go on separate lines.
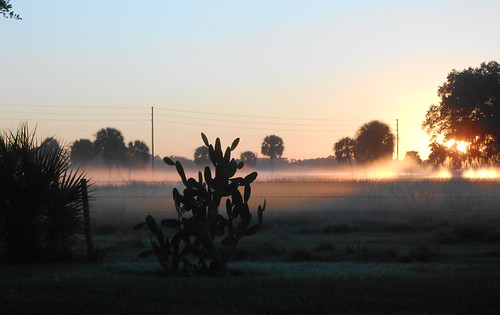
top-left (0, 180), bottom-right (500, 314)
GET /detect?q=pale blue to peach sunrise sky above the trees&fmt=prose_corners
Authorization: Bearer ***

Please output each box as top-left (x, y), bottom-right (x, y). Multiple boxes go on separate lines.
top-left (0, 0), bottom-right (500, 159)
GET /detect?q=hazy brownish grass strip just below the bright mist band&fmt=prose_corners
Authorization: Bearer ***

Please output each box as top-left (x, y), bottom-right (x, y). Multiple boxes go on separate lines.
top-left (92, 180), bottom-right (500, 229)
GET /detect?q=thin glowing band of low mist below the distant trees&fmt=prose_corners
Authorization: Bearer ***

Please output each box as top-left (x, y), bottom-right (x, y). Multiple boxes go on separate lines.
top-left (79, 160), bottom-right (500, 185)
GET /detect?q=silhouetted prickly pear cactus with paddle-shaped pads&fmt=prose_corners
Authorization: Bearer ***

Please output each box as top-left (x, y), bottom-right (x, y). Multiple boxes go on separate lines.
top-left (134, 133), bottom-right (266, 276)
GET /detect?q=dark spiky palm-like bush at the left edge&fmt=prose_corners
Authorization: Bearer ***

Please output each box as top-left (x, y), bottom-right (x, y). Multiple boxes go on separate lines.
top-left (0, 124), bottom-right (83, 263)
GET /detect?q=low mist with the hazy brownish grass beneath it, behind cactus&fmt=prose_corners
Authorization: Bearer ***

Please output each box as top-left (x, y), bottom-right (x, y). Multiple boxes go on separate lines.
top-left (86, 162), bottom-right (500, 239)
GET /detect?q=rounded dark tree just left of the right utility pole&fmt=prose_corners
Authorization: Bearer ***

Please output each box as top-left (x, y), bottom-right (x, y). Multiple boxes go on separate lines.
top-left (354, 120), bottom-right (394, 163)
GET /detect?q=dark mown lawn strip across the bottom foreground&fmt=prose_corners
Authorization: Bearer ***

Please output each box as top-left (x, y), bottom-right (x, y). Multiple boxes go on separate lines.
top-left (0, 262), bottom-right (500, 314)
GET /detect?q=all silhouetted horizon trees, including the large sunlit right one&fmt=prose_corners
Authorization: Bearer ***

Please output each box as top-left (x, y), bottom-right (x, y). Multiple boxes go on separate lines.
top-left (49, 61), bottom-right (500, 173)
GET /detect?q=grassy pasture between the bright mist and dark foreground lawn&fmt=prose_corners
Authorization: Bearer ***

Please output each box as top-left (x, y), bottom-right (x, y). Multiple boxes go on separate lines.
top-left (88, 180), bottom-right (500, 262)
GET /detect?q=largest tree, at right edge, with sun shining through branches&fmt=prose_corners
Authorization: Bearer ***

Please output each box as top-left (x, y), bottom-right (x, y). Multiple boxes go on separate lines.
top-left (422, 61), bottom-right (500, 164)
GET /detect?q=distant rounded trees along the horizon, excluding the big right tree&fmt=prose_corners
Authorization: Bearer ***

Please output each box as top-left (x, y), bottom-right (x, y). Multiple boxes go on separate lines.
top-left (53, 121), bottom-right (394, 168)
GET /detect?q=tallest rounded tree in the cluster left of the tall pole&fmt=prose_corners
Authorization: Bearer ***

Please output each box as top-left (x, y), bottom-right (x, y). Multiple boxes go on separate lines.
top-left (94, 127), bottom-right (128, 165)
